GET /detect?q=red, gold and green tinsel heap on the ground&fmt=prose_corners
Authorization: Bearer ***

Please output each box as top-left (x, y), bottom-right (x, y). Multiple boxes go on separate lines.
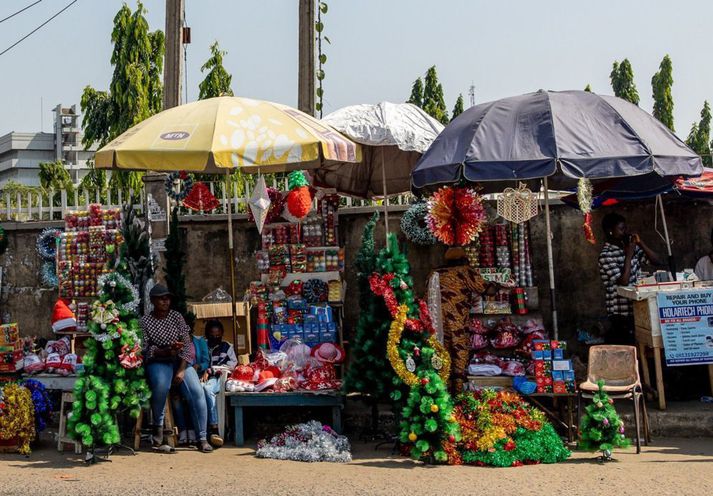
top-left (453, 389), bottom-right (570, 467)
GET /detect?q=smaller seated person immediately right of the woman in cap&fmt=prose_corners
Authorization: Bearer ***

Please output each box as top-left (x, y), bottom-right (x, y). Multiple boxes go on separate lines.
top-left (201, 320), bottom-right (238, 447)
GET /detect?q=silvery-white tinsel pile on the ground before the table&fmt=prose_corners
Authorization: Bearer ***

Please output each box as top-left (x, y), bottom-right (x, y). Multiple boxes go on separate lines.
top-left (255, 420), bottom-right (352, 463)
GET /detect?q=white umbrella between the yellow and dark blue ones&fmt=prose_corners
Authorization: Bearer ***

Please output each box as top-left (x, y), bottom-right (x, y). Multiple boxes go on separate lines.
top-left (312, 102), bottom-right (443, 198)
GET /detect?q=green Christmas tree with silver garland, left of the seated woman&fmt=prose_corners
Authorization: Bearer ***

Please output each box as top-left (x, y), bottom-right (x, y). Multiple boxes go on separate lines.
top-left (67, 272), bottom-right (151, 460)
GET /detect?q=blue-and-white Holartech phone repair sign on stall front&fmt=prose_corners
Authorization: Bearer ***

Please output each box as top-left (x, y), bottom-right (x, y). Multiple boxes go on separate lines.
top-left (657, 289), bottom-right (713, 366)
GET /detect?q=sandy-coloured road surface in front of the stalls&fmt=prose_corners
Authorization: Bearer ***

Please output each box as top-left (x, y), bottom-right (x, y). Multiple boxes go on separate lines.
top-left (0, 439), bottom-right (713, 496)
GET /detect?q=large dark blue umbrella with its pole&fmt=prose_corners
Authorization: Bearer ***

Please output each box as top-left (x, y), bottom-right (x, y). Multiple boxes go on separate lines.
top-left (411, 90), bottom-right (703, 336)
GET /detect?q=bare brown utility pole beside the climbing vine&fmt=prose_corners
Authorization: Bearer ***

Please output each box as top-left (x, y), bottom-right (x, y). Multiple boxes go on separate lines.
top-left (297, 0), bottom-right (316, 116)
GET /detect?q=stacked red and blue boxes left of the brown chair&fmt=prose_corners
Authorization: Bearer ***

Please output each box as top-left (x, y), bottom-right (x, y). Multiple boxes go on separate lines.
top-left (532, 339), bottom-right (576, 394)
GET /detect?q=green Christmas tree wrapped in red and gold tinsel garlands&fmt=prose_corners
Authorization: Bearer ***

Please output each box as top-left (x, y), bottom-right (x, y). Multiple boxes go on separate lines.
top-left (371, 234), bottom-right (460, 463)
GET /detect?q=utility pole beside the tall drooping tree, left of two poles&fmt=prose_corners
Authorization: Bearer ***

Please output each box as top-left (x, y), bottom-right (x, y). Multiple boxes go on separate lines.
top-left (163, 0), bottom-right (185, 110)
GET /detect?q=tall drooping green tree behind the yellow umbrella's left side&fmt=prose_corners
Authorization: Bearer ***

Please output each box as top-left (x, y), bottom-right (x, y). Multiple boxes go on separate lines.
top-left (81, 2), bottom-right (164, 196)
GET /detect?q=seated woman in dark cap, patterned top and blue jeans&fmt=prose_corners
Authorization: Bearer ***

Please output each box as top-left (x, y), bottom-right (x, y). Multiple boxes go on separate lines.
top-left (141, 284), bottom-right (213, 453)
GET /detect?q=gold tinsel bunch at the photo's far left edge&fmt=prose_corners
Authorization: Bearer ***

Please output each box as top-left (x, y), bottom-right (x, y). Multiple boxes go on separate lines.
top-left (0, 384), bottom-right (35, 455)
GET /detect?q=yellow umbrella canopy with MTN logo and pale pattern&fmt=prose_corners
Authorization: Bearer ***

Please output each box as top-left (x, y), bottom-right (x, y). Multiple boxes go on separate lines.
top-left (95, 96), bottom-right (361, 173)
